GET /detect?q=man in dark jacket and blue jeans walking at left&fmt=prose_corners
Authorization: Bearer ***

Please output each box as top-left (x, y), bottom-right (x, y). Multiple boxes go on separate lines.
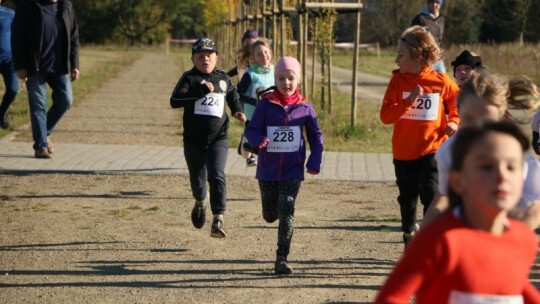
top-left (11, 0), bottom-right (80, 158)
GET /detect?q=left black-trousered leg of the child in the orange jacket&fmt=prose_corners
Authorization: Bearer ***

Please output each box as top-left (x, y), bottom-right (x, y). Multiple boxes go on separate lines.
top-left (394, 160), bottom-right (420, 234)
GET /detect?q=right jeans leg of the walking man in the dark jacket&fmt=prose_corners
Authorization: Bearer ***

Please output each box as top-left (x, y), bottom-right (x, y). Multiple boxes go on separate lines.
top-left (47, 74), bottom-right (73, 135)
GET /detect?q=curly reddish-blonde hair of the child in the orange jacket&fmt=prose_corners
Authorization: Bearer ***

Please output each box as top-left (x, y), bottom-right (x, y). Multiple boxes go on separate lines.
top-left (398, 25), bottom-right (442, 66)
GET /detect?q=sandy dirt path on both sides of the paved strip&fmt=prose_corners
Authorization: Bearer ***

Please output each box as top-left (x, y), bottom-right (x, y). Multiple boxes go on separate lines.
top-left (0, 54), bottom-right (539, 304)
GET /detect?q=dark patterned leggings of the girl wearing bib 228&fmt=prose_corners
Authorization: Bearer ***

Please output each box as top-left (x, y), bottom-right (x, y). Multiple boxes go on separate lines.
top-left (259, 179), bottom-right (302, 258)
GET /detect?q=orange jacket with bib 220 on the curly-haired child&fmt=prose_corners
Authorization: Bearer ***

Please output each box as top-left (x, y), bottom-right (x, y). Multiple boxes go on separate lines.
top-left (381, 67), bottom-right (459, 160)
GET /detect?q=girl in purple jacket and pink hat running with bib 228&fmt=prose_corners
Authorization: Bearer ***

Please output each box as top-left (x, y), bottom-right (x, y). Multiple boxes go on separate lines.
top-left (245, 56), bottom-right (323, 274)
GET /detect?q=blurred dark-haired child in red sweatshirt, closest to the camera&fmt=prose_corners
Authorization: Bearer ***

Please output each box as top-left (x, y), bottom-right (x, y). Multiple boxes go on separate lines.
top-left (375, 121), bottom-right (540, 304)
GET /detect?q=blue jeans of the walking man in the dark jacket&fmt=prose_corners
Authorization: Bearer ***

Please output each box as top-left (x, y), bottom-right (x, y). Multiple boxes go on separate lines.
top-left (26, 72), bottom-right (73, 149)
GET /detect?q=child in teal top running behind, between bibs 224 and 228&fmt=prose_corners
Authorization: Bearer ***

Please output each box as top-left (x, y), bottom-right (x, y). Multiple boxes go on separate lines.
top-left (238, 38), bottom-right (274, 167)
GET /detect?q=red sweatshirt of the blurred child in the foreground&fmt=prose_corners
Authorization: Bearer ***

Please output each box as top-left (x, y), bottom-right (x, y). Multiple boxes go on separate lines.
top-left (375, 210), bottom-right (540, 304)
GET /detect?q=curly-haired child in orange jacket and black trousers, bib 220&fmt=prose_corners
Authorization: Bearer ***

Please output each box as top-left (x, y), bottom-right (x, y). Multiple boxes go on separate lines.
top-left (380, 26), bottom-right (459, 244)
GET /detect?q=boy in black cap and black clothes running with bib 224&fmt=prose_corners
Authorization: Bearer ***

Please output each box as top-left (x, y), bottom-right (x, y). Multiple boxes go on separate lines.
top-left (170, 38), bottom-right (246, 238)
